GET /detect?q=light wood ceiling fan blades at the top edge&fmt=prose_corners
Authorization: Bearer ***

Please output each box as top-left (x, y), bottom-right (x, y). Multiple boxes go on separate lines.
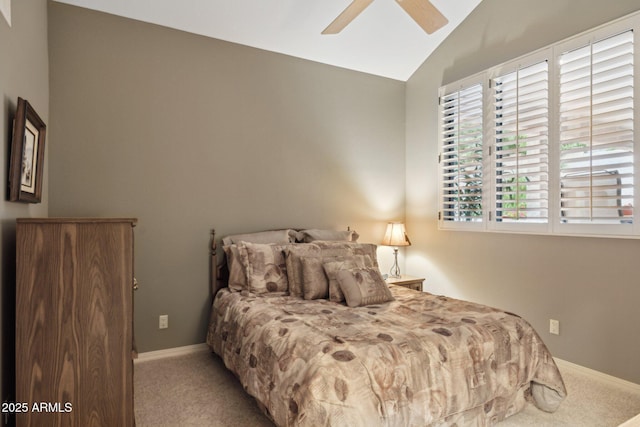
top-left (322, 0), bottom-right (449, 34)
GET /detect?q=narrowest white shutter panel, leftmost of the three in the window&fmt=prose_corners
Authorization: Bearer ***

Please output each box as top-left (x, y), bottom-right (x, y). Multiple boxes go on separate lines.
top-left (440, 84), bottom-right (483, 222)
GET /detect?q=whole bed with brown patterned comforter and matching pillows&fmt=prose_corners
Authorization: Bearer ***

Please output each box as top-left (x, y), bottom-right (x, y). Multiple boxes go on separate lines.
top-left (207, 230), bottom-right (566, 426)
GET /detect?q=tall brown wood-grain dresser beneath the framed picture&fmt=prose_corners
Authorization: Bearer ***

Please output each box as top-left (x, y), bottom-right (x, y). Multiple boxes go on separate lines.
top-left (16, 218), bottom-right (136, 427)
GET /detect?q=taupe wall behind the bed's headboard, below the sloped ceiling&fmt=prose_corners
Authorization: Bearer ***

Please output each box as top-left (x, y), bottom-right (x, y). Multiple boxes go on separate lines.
top-left (49, 3), bottom-right (405, 351)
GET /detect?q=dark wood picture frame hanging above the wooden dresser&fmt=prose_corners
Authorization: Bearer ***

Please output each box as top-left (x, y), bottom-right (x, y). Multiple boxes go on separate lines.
top-left (9, 98), bottom-right (47, 203)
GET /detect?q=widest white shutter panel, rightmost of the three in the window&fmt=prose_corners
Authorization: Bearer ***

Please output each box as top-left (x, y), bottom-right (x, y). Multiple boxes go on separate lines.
top-left (559, 31), bottom-right (634, 224)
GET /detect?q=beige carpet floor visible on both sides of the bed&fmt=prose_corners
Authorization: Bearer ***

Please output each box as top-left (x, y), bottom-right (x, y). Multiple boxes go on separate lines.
top-left (135, 351), bottom-right (640, 427)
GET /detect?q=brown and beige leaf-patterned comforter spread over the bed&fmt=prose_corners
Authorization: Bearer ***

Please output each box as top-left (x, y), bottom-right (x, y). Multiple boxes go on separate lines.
top-left (207, 285), bottom-right (566, 427)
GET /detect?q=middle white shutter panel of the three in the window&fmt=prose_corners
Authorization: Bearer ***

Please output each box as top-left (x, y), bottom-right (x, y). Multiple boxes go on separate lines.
top-left (491, 61), bottom-right (549, 223)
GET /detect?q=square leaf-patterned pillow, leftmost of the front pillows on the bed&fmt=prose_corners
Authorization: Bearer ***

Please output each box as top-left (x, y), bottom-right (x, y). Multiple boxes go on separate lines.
top-left (238, 242), bottom-right (289, 294)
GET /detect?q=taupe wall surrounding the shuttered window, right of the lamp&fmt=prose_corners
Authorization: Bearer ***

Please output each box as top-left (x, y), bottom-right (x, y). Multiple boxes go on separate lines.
top-left (406, 0), bottom-right (640, 383)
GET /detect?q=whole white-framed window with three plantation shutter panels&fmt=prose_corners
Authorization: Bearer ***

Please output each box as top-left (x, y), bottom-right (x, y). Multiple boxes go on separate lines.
top-left (439, 13), bottom-right (640, 237)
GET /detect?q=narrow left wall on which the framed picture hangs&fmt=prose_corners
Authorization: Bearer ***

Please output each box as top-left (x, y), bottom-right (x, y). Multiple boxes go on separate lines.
top-left (0, 0), bottom-right (53, 401)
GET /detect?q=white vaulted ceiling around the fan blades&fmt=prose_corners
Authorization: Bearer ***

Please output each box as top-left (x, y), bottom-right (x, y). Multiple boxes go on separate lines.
top-left (51, 0), bottom-right (482, 81)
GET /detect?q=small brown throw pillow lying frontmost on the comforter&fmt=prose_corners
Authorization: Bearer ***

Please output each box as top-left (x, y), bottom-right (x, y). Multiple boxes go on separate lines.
top-left (337, 267), bottom-right (394, 307)
